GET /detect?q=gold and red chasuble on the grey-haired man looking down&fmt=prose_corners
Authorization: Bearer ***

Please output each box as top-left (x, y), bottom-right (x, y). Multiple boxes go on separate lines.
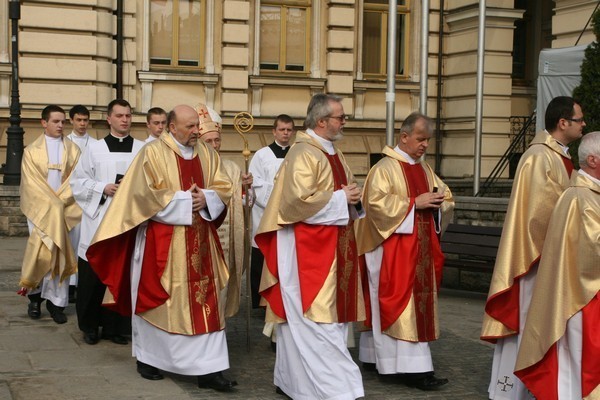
top-left (356, 147), bottom-right (454, 342)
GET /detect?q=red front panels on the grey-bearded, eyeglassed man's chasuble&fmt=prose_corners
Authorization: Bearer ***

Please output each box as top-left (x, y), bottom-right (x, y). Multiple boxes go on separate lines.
top-left (294, 154), bottom-right (360, 322)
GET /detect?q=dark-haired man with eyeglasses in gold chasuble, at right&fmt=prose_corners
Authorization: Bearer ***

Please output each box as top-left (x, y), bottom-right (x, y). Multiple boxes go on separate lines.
top-left (481, 96), bottom-right (585, 400)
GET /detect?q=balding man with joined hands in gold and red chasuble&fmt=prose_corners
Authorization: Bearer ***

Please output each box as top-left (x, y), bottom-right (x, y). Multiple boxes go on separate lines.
top-left (87, 105), bottom-right (235, 391)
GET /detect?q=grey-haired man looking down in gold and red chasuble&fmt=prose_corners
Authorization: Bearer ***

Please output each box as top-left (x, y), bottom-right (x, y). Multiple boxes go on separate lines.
top-left (357, 112), bottom-right (454, 390)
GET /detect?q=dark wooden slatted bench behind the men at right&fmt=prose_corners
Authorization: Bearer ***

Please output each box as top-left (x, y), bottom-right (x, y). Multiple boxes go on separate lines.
top-left (441, 224), bottom-right (502, 287)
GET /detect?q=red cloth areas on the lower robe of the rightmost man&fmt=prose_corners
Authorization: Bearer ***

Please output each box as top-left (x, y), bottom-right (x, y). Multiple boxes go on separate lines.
top-left (515, 294), bottom-right (600, 400)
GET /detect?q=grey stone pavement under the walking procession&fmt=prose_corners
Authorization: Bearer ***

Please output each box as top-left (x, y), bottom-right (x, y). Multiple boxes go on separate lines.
top-left (0, 238), bottom-right (493, 400)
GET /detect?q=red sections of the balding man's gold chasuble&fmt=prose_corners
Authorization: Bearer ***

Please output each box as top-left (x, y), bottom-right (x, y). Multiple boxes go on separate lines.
top-left (87, 156), bottom-right (226, 335)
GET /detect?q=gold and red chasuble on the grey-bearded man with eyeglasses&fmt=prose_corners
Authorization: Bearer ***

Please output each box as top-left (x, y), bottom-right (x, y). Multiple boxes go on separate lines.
top-left (255, 132), bottom-right (365, 323)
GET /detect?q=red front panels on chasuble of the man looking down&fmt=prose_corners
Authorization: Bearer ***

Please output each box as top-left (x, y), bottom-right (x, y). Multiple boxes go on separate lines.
top-left (379, 161), bottom-right (444, 342)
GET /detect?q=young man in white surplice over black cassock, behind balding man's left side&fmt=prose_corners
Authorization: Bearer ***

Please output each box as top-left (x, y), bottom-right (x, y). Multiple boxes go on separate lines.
top-left (71, 99), bottom-right (144, 344)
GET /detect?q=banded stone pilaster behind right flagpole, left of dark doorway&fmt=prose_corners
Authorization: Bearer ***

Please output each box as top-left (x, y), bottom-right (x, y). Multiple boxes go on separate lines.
top-left (442, 1), bottom-right (523, 177)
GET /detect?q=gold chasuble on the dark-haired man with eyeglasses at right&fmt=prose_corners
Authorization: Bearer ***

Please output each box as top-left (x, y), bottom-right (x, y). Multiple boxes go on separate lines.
top-left (481, 131), bottom-right (573, 342)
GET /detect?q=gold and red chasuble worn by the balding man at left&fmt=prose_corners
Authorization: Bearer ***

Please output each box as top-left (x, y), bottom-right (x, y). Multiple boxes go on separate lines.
top-left (87, 134), bottom-right (232, 335)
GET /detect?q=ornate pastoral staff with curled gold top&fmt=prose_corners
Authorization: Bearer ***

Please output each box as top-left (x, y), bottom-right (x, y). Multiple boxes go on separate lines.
top-left (233, 112), bottom-right (254, 351)
